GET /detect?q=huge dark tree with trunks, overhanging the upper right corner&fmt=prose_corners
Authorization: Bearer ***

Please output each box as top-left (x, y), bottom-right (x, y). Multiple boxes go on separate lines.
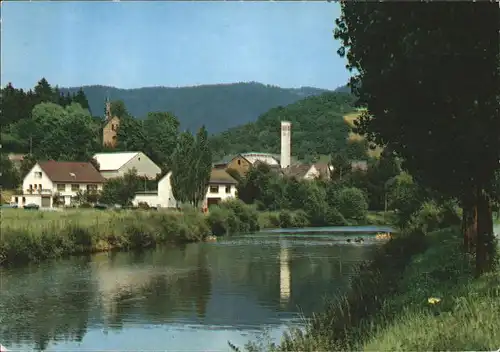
top-left (335, 2), bottom-right (500, 274)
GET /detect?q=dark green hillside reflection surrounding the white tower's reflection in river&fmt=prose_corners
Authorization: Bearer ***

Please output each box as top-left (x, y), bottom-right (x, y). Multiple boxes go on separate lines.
top-left (207, 239), bottom-right (378, 315)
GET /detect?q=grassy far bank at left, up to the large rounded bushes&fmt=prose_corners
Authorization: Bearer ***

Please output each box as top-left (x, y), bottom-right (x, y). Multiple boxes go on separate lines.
top-left (0, 209), bottom-right (210, 265)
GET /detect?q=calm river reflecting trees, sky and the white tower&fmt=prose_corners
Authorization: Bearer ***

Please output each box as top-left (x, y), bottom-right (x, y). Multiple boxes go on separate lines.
top-left (0, 233), bottom-right (378, 351)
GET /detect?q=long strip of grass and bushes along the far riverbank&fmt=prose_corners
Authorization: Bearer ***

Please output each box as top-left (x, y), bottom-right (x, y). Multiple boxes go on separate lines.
top-left (0, 200), bottom-right (374, 266)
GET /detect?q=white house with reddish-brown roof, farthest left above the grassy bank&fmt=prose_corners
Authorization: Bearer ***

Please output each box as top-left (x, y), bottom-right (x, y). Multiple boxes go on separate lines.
top-left (11, 160), bottom-right (106, 208)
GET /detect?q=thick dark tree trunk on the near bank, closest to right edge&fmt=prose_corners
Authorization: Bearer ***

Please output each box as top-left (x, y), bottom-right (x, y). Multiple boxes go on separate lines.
top-left (476, 187), bottom-right (495, 276)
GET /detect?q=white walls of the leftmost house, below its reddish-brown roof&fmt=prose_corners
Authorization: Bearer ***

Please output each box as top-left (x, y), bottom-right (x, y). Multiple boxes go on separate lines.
top-left (12, 164), bottom-right (103, 207)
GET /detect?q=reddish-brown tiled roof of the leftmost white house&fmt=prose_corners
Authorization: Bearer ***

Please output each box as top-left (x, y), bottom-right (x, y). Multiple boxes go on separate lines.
top-left (38, 160), bottom-right (105, 183)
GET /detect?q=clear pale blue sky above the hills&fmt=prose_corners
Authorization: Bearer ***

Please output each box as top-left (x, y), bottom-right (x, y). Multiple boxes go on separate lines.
top-left (1, 1), bottom-right (349, 89)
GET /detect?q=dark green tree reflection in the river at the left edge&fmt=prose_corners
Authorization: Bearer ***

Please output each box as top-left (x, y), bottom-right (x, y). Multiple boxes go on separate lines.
top-left (0, 258), bottom-right (94, 350)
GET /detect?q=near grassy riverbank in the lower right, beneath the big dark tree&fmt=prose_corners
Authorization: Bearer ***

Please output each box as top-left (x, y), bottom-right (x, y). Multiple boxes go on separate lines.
top-left (240, 228), bottom-right (500, 351)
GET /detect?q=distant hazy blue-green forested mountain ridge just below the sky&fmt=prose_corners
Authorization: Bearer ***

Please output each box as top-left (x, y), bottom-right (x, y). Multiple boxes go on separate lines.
top-left (61, 82), bottom-right (332, 133)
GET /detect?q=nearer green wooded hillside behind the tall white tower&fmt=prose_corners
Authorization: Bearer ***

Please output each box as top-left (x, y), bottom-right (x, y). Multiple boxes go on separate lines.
top-left (208, 92), bottom-right (367, 160)
